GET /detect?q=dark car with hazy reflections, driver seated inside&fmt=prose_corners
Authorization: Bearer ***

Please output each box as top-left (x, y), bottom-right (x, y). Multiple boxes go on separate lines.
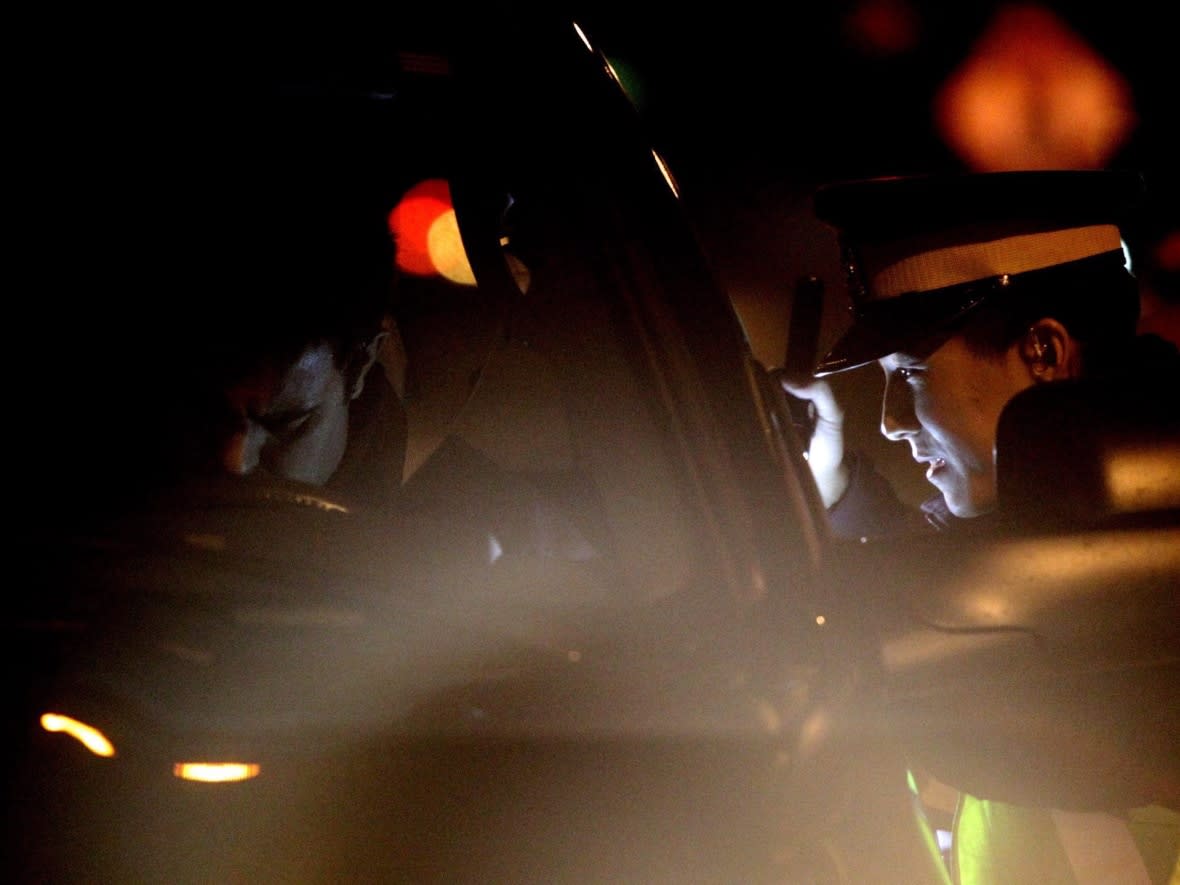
top-left (6, 8), bottom-right (1180, 885)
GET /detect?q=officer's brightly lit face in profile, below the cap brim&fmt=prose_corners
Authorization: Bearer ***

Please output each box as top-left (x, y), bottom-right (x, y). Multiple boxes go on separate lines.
top-left (878, 335), bottom-right (1029, 517)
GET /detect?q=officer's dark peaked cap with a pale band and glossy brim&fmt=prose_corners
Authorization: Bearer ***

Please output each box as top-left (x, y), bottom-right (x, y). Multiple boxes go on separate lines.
top-left (813, 170), bottom-right (1145, 375)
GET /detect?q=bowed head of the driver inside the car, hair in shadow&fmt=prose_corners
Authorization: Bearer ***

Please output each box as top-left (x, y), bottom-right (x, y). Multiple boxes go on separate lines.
top-left (193, 189), bottom-right (394, 485)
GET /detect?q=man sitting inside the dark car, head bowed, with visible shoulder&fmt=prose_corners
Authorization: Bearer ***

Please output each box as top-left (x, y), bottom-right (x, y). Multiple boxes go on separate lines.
top-left (189, 181), bottom-right (597, 561)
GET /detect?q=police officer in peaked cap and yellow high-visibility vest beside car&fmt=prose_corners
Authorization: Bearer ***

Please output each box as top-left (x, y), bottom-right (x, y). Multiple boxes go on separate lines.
top-left (784, 171), bottom-right (1180, 885)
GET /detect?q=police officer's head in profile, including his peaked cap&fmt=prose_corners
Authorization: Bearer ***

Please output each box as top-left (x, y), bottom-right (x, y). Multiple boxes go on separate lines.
top-left (815, 172), bottom-right (1141, 517)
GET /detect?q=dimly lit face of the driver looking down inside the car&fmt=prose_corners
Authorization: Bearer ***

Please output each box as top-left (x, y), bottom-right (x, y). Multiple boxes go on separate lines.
top-left (221, 345), bottom-right (348, 485)
